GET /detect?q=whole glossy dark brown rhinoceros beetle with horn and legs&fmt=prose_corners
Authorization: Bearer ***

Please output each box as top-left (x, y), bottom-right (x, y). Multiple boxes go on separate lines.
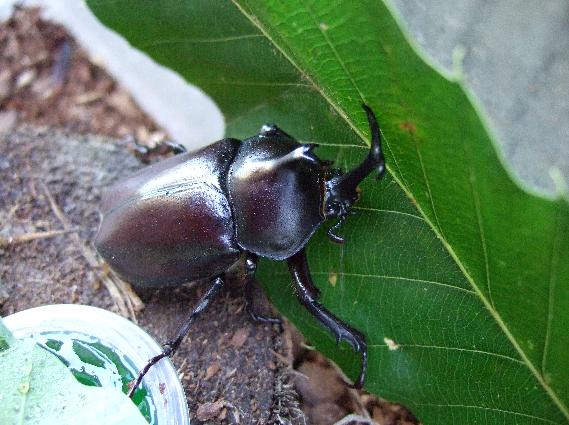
top-left (95, 105), bottom-right (385, 396)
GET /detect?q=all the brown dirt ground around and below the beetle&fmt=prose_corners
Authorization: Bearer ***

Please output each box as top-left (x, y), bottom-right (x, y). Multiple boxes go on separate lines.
top-left (0, 10), bottom-right (418, 425)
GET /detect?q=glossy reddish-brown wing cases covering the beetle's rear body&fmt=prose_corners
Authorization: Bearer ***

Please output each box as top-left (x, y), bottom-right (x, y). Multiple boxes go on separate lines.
top-left (95, 139), bottom-right (240, 286)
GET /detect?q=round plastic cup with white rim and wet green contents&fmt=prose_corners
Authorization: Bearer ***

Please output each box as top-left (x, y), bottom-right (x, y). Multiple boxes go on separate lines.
top-left (4, 304), bottom-right (190, 425)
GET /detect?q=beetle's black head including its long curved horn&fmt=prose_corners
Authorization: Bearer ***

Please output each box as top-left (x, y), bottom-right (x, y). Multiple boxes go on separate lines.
top-left (324, 105), bottom-right (385, 243)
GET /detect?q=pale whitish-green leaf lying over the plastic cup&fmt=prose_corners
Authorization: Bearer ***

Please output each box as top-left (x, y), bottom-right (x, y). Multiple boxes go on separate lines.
top-left (0, 320), bottom-right (148, 425)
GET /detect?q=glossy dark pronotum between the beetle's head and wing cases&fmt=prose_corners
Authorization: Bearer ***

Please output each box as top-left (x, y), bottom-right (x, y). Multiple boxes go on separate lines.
top-left (227, 136), bottom-right (324, 260)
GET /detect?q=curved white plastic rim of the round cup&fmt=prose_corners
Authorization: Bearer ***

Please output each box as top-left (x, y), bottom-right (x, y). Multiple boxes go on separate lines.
top-left (2, 304), bottom-right (190, 425)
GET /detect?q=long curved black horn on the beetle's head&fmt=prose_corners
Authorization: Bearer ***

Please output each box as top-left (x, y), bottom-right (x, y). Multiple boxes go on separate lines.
top-left (338, 104), bottom-right (385, 193)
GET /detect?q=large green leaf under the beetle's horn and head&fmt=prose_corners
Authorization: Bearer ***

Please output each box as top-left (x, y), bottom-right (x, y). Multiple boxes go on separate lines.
top-left (88, 0), bottom-right (569, 425)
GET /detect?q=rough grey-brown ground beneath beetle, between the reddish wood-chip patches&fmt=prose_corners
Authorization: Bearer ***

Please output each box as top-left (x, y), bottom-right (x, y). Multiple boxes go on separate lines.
top-left (0, 127), bottom-right (298, 423)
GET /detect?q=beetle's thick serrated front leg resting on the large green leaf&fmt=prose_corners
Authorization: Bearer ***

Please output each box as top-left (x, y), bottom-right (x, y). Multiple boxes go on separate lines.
top-left (287, 248), bottom-right (367, 388)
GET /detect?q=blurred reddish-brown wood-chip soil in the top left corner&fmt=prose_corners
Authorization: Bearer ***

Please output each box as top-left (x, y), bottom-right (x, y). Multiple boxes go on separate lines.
top-left (0, 9), bottom-right (163, 141)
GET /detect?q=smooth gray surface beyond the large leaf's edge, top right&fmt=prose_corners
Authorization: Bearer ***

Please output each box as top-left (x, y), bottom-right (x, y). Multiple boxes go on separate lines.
top-left (393, 0), bottom-right (569, 190)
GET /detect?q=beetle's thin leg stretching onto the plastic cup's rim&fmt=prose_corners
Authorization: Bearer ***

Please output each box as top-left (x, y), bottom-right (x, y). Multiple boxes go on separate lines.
top-left (127, 276), bottom-right (224, 398)
